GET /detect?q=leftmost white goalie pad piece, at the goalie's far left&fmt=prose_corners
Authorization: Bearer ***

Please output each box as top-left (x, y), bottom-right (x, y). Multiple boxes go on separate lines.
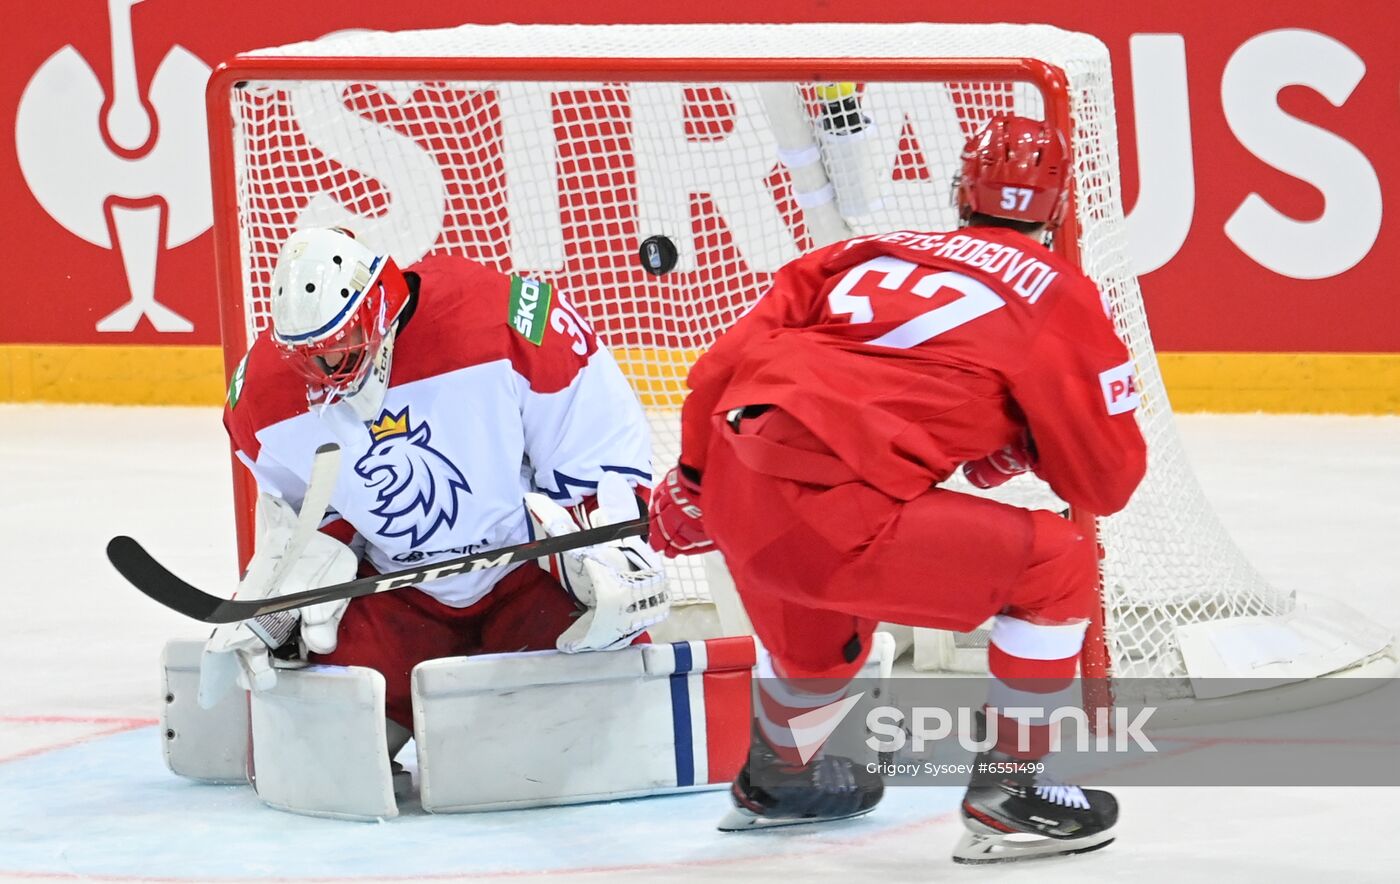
top-left (161, 639), bottom-right (248, 783)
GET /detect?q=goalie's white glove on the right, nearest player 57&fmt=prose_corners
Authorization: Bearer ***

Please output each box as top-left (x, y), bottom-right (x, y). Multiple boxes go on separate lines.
top-left (525, 472), bottom-right (671, 654)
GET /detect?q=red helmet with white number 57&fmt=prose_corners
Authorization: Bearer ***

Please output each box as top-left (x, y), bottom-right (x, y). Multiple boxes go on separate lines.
top-left (955, 115), bottom-right (1070, 230)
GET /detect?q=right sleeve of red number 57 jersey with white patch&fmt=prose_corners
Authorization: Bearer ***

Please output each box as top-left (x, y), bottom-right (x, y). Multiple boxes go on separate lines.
top-left (1009, 280), bottom-right (1147, 516)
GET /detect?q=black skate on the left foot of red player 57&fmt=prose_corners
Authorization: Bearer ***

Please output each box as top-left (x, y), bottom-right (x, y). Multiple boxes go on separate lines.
top-left (720, 737), bottom-right (885, 832)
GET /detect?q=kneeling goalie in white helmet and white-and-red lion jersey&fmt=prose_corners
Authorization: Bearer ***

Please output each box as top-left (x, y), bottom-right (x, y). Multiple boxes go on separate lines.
top-left (202, 230), bottom-right (669, 745)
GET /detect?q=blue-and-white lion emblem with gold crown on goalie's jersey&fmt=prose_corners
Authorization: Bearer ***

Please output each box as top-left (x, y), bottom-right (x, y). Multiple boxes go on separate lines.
top-left (354, 406), bottom-right (472, 546)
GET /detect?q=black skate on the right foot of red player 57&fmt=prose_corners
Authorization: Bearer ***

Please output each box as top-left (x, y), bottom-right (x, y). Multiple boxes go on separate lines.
top-left (953, 751), bottom-right (1119, 863)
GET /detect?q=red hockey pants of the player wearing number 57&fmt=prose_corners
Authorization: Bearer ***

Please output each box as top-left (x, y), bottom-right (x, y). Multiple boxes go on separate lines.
top-left (701, 409), bottom-right (1098, 678)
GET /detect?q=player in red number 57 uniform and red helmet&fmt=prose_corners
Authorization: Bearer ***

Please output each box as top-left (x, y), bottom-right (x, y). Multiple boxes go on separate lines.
top-left (651, 116), bottom-right (1145, 862)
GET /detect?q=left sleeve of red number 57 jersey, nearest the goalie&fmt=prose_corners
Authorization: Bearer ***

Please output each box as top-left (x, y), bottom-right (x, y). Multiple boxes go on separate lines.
top-left (680, 242), bottom-right (844, 474)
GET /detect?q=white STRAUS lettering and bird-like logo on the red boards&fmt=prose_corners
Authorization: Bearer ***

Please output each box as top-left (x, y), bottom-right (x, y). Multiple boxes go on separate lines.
top-left (15, 14), bottom-right (1382, 332)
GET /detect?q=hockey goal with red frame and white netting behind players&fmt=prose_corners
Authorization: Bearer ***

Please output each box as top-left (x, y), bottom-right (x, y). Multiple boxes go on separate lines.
top-left (209, 24), bottom-right (1390, 722)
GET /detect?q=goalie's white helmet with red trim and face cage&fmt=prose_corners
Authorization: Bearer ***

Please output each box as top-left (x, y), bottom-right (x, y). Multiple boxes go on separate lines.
top-left (272, 228), bottom-right (409, 403)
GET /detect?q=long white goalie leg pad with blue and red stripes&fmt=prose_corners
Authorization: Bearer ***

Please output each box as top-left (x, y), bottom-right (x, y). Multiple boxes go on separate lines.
top-left (413, 636), bottom-right (755, 813)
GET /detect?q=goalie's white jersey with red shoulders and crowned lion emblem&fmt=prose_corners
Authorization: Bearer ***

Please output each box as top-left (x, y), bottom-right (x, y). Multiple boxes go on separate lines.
top-left (224, 255), bottom-right (651, 608)
